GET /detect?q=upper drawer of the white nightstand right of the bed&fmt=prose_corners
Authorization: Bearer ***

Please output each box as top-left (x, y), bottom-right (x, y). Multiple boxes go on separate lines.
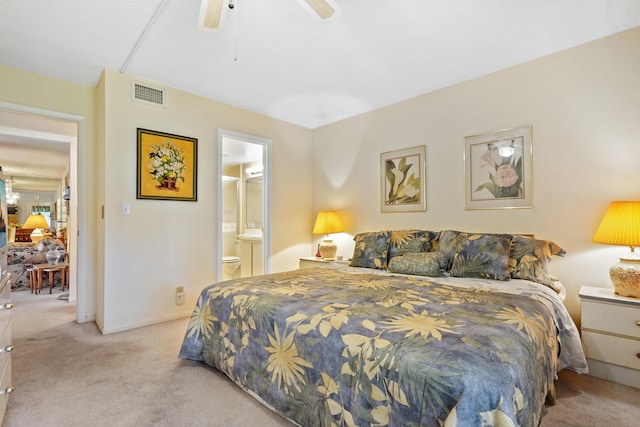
top-left (582, 299), bottom-right (640, 339)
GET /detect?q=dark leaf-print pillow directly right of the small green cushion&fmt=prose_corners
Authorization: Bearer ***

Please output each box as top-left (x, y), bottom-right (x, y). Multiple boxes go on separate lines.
top-left (451, 233), bottom-right (513, 280)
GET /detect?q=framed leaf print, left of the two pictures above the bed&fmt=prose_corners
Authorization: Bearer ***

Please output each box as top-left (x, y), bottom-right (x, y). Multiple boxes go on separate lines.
top-left (380, 145), bottom-right (427, 212)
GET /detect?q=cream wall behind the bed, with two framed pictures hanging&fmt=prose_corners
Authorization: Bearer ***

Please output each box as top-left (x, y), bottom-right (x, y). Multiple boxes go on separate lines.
top-left (312, 28), bottom-right (640, 319)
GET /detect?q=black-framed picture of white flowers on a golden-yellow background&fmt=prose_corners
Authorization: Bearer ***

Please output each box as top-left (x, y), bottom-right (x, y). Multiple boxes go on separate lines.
top-left (136, 128), bottom-right (198, 202)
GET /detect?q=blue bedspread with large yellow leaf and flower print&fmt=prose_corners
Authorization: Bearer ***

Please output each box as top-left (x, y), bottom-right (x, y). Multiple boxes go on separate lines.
top-left (179, 268), bottom-right (586, 427)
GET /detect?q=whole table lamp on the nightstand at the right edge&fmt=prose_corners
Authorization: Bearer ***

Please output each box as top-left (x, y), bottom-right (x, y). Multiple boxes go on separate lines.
top-left (593, 201), bottom-right (640, 298)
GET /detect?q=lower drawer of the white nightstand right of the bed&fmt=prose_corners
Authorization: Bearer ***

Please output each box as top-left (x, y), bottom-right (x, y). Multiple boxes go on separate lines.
top-left (582, 331), bottom-right (640, 369)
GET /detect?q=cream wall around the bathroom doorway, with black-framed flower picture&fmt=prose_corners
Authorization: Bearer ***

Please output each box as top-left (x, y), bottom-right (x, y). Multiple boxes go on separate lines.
top-left (99, 70), bottom-right (312, 333)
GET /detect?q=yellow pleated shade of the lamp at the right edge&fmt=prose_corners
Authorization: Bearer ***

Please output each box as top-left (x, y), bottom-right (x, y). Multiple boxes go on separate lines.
top-left (593, 201), bottom-right (640, 251)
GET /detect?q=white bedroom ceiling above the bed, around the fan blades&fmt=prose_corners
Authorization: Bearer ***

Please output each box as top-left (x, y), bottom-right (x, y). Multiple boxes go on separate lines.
top-left (0, 0), bottom-right (640, 186)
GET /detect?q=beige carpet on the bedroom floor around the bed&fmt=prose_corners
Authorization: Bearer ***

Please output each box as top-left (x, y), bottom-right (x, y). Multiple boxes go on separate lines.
top-left (3, 290), bottom-right (640, 427)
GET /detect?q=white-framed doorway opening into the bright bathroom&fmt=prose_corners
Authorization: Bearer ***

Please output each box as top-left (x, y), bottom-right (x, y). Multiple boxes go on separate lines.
top-left (216, 129), bottom-right (271, 280)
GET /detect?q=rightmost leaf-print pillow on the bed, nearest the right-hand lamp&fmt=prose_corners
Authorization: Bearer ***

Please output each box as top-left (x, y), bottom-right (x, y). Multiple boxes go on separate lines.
top-left (510, 236), bottom-right (566, 289)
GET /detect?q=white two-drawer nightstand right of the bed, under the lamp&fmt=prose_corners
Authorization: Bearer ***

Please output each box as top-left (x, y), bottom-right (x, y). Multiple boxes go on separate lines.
top-left (580, 286), bottom-right (640, 388)
